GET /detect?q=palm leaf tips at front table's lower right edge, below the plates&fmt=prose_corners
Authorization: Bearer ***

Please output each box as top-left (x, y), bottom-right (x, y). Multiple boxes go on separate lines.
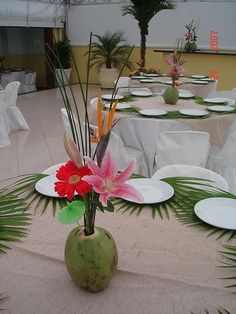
top-left (219, 245), bottom-right (236, 293)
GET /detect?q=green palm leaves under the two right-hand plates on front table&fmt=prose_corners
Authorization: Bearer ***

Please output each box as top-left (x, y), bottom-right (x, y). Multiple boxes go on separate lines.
top-left (113, 177), bottom-right (236, 241)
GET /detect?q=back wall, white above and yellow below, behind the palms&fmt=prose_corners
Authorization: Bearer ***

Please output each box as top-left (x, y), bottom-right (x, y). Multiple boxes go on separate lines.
top-left (68, 1), bottom-right (236, 90)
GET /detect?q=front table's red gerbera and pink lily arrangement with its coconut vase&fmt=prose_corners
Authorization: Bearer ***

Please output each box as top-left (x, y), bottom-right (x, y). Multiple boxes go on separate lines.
top-left (48, 34), bottom-right (143, 292)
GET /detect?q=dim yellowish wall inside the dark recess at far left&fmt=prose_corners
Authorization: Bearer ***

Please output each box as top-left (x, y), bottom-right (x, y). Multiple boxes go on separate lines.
top-left (4, 55), bottom-right (46, 87)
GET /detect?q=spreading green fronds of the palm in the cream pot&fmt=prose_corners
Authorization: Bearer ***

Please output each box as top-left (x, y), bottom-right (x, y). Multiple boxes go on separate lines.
top-left (90, 32), bottom-right (131, 69)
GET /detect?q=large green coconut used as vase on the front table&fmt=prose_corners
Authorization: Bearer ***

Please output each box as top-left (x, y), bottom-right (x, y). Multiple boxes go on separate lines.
top-left (65, 226), bottom-right (118, 292)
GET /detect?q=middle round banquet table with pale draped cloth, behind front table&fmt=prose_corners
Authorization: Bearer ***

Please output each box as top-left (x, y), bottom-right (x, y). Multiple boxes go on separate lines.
top-left (89, 95), bottom-right (236, 177)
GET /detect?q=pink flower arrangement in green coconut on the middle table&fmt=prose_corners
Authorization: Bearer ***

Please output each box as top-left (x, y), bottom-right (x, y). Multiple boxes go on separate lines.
top-left (163, 48), bottom-right (185, 105)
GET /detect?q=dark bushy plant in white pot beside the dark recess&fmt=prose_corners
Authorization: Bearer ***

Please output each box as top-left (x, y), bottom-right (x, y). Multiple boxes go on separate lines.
top-left (53, 37), bottom-right (71, 85)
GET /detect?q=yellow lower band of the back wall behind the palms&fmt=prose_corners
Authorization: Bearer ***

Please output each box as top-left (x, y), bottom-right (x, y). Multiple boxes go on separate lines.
top-left (71, 46), bottom-right (236, 90)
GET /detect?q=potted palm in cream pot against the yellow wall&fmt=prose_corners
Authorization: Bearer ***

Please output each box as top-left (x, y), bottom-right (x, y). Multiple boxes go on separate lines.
top-left (91, 32), bottom-right (131, 88)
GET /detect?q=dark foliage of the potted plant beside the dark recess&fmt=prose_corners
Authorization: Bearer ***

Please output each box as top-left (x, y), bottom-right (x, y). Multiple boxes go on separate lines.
top-left (53, 37), bottom-right (71, 69)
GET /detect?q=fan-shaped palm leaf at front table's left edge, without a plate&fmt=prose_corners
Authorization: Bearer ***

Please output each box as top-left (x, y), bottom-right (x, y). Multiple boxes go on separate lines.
top-left (0, 195), bottom-right (30, 253)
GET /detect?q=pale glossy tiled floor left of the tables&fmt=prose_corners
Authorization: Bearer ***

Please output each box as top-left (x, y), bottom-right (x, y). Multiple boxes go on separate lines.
top-left (0, 85), bottom-right (101, 186)
